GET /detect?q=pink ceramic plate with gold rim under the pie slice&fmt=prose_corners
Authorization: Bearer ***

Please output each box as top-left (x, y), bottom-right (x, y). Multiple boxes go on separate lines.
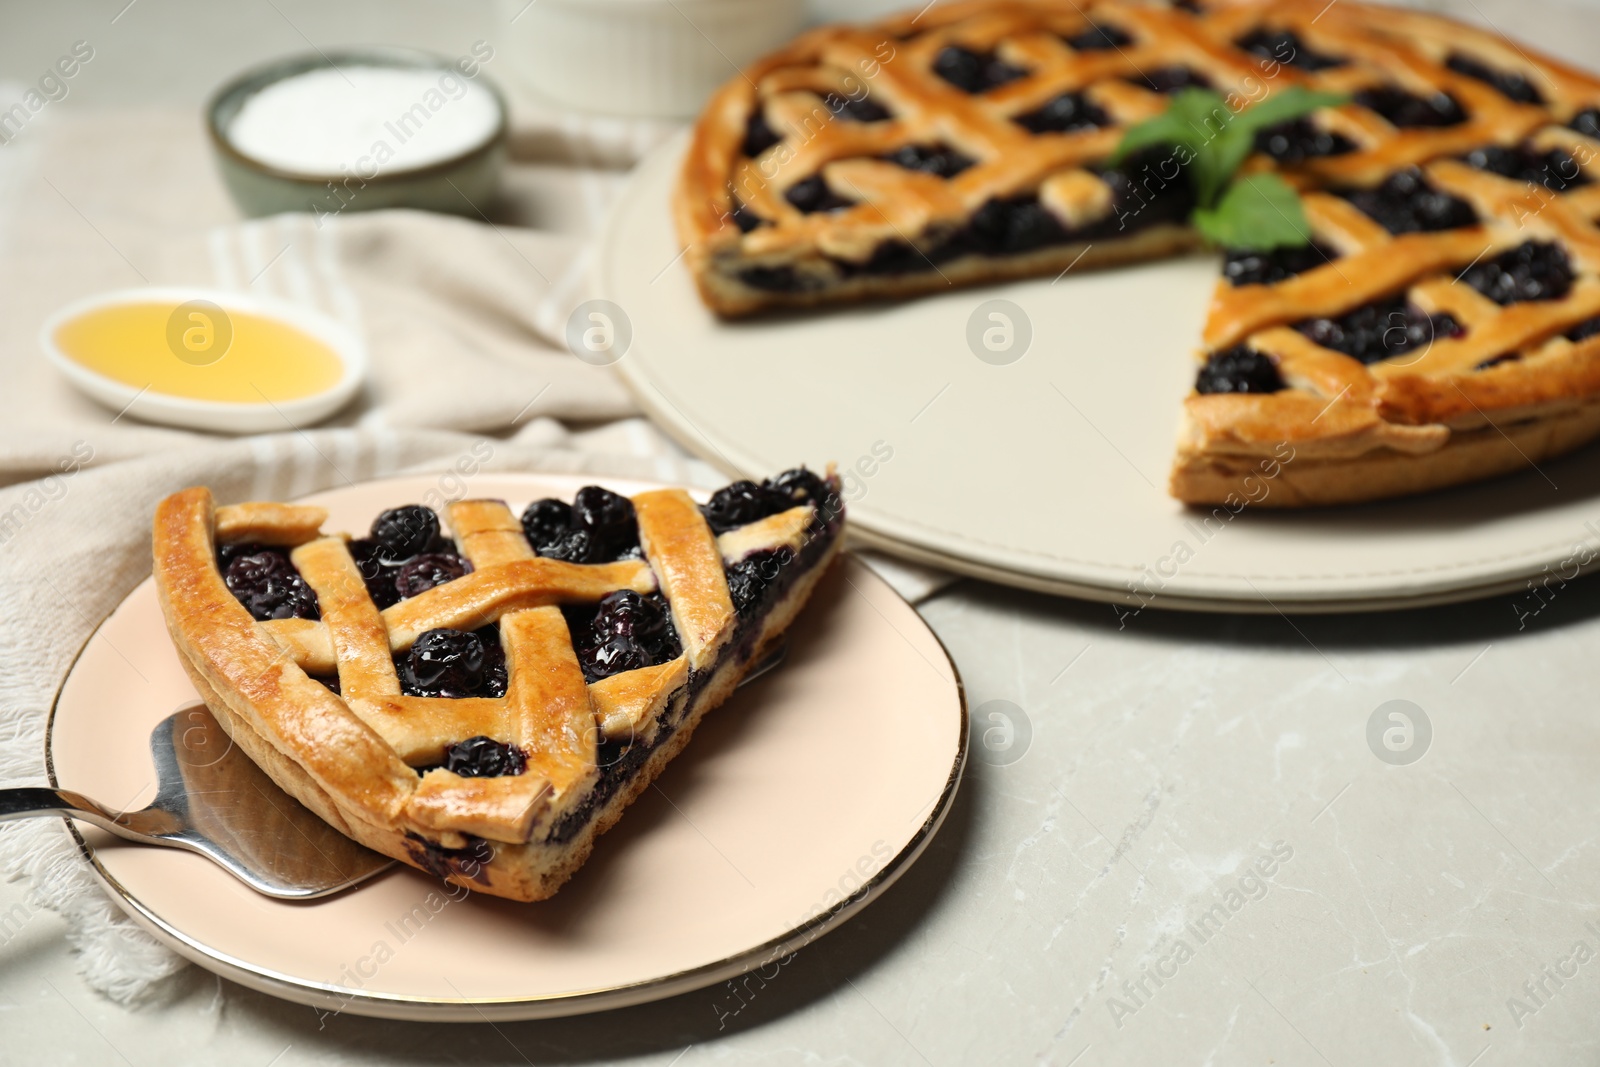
top-left (50, 475), bottom-right (966, 1021)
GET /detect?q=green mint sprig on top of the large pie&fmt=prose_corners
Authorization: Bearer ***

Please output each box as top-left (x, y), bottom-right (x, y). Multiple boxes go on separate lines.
top-left (1110, 85), bottom-right (1349, 251)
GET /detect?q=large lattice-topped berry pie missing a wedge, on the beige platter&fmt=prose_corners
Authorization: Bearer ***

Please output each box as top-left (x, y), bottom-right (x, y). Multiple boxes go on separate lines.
top-left (674, 0), bottom-right (1600, 507)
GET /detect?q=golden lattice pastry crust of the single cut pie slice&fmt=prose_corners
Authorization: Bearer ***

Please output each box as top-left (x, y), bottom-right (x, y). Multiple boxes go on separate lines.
top-left (155, 482), bottom-right (842, 901)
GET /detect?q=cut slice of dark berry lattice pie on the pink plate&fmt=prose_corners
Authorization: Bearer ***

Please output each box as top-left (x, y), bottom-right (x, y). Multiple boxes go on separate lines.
top-left (155, 467), bottom-right (845, 901)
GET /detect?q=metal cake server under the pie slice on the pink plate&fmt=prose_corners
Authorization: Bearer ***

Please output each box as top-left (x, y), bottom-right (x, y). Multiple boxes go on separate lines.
top-left (0, 641), bottom-right (789, 901)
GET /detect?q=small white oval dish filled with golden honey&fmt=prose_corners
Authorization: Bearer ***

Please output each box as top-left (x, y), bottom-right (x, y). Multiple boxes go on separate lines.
top-left (38, 288), bottom-right (366, 434)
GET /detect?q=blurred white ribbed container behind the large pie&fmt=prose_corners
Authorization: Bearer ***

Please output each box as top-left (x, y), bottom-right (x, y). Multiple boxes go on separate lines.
top-left (502, 0), bottom-right (806, 118)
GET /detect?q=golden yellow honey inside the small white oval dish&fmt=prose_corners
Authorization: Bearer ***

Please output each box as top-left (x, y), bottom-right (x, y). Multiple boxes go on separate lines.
top-left (54, 301), bottom-right (344, 403)
